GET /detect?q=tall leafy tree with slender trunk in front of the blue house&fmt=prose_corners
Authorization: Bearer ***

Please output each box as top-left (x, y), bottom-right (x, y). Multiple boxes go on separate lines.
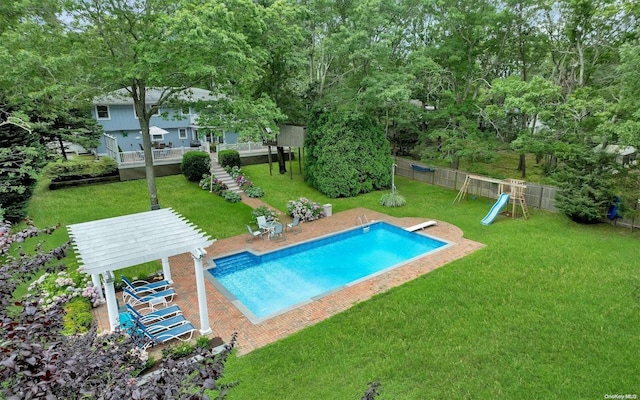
top-left (68, 0), bottom-right (265, 209)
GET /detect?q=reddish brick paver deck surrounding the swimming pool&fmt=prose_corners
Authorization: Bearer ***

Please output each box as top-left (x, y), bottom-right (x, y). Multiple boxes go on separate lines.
top-left (94, 205), bottom-right (484, 355)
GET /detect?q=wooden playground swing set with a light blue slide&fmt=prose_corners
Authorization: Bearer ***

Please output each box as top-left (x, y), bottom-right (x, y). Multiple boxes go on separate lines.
top-left (453, 175), bottom-right (529, 225)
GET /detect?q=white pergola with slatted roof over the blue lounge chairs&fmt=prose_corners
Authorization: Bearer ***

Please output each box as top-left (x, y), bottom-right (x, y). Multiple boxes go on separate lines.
top-left (67, 208), bottom-right (215, 335)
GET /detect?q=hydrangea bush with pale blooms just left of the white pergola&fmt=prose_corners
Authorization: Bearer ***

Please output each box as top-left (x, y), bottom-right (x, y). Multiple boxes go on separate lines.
top-left (28, 271), bottom-right (101, 310)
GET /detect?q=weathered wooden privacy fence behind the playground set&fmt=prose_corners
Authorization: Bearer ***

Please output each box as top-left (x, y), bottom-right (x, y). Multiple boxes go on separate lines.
top-left (395, 158), bottom-right (640, 228)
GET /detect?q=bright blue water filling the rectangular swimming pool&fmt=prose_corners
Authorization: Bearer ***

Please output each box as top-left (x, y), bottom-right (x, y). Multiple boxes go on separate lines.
top-left (208, 222), bottom-right (447, 322)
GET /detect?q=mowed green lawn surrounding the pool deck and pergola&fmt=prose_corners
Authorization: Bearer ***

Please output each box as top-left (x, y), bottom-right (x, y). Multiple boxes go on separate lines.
top-left (22, 164), bottom-right (640, 400)
